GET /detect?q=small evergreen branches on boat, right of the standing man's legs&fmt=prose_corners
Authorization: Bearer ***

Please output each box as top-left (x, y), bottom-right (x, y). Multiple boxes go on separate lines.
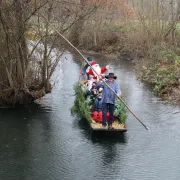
top-left (115, 99), bottom-right (128, 124)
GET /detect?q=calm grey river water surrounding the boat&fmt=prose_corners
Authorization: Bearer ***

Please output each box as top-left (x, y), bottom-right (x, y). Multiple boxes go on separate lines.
top-left (0, 54), bottom-right (180, 180)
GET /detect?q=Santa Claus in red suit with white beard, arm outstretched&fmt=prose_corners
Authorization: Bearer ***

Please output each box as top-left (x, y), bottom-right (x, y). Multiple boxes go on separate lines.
top-left (86, 61), bottom-right (109, 81)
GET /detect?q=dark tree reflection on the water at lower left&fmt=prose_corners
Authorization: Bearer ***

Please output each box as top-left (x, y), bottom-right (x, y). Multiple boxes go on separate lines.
top-left (0, 103), bottom-right (52, 179)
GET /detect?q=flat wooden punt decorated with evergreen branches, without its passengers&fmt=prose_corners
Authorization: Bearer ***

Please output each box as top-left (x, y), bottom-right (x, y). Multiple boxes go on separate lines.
top-left (71, 82), bottom-right (127, 132)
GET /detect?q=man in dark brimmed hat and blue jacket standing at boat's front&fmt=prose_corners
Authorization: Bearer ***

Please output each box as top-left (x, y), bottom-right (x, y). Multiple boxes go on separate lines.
top-left (102, 73), bottom-right (122, 129)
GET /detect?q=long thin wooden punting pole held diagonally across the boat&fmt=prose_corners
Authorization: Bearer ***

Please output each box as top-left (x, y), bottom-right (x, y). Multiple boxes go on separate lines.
top-left (46, 20), bottom-right (149, 130)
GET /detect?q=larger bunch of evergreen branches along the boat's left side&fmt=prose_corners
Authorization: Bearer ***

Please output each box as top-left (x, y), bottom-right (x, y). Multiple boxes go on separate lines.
top-left (71, 84), bottom-right (92, 122)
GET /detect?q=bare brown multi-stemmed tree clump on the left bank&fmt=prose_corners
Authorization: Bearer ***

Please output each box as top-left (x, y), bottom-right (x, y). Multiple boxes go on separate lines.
top-left (0, 0), bottom-right (102, 105)
